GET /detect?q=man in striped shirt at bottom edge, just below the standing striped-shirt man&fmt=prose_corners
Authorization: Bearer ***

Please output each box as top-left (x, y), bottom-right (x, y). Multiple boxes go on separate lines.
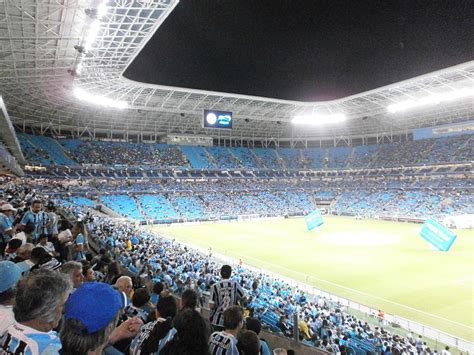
top-left (209, 306), bottom-right (244, 355)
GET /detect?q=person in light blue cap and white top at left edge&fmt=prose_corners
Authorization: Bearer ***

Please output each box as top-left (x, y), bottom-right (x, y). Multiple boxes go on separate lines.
top-left (0, 261), bottom-right (21, 337)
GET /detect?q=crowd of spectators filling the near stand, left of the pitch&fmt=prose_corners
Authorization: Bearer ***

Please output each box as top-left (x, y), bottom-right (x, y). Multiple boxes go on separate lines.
top-left (0, 180), bottom-right (460, 355)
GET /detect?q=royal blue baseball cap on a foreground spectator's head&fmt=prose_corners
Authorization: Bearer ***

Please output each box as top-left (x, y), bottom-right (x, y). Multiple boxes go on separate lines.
top-left (64, 282), bottom-right (126, 334)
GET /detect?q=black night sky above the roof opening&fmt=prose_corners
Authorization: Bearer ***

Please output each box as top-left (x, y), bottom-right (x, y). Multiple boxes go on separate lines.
top-left (125, 0), bottom-right (474, 101)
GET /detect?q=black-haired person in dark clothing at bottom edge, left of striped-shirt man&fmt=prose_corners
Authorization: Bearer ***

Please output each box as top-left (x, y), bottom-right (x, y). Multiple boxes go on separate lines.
top-left (160, 308), bottom-right (209, 355)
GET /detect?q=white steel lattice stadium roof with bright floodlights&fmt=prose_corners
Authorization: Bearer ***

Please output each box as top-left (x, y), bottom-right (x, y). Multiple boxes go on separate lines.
top-left (0, 0), bottom-right (474, 140)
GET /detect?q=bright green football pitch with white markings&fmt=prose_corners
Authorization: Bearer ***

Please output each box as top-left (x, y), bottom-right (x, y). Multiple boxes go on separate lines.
top-left (146, 216), bottom-right (474, 341)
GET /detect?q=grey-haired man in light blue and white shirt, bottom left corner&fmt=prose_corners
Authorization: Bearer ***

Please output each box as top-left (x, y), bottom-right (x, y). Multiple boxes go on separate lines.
top-left (0, 270), bottom-right (72, 355)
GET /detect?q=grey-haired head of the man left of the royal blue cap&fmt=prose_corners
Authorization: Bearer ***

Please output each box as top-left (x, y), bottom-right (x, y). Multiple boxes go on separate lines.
top-left (13, 269), bottom-right (72, 332)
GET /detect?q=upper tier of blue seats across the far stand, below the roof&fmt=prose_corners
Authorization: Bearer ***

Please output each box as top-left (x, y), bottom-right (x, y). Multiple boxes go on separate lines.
top-left (14, 134), bottom-right (474, 170)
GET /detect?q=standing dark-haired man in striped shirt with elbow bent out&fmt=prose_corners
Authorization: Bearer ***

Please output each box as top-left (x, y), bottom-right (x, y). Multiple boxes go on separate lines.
top-left (209, 265), bottom-right (246, 330)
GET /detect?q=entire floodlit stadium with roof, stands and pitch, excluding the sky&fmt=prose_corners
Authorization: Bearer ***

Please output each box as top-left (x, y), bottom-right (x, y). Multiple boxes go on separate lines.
top-left (0, 0), bottom-right (474, 355)
